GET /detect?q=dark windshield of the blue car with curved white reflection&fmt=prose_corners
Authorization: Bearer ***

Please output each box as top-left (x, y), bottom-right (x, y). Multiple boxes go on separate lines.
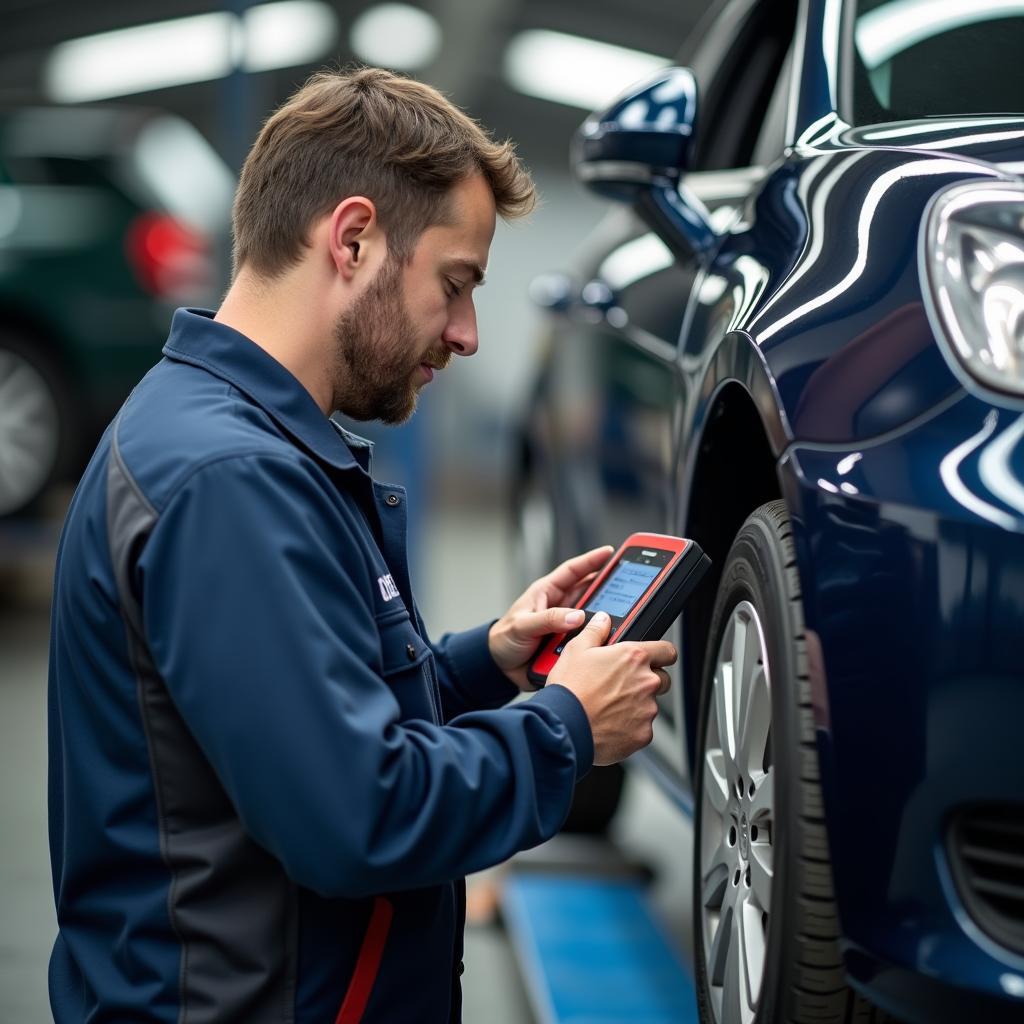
top-left (851, 0), bottom-right (1024, 125)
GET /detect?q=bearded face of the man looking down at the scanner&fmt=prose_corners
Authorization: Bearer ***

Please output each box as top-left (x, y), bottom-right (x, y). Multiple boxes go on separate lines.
top-left (333, 175), bottom-right (495, 423)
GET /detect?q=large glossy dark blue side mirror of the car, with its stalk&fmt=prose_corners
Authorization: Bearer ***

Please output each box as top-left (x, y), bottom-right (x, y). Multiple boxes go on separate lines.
top-left (572, 68), bottom-right (717, 259)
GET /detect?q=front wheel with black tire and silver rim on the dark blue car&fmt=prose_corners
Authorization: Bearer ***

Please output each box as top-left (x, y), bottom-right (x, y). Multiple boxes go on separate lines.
top-left (693, 502), bottom-right (893, 1024)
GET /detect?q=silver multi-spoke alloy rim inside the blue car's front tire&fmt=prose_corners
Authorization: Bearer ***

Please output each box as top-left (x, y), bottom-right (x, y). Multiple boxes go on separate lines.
top-left (698, 601), bottom-right (775, 1024)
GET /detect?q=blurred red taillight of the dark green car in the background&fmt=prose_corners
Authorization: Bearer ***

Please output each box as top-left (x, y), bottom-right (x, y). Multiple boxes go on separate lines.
top-left (125, 213), bottom-right (213, 301)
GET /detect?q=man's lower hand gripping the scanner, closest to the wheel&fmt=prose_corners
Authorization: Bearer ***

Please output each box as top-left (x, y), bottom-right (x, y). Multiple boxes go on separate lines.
top-left (548, 611), bottom-right (677, 765)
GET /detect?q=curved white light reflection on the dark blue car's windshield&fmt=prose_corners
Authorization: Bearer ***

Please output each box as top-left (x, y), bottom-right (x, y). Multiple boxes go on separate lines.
top-left (855, 0), bottom-right (1024, 71)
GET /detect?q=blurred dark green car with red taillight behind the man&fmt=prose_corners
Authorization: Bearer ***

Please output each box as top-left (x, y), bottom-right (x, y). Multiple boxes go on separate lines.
top-left (0, 106), bottom-right (234, 517)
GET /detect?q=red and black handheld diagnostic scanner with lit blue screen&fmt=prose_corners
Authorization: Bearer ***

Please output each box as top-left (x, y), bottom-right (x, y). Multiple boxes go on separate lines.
top-left (526, 534), bottom-right (711, 689)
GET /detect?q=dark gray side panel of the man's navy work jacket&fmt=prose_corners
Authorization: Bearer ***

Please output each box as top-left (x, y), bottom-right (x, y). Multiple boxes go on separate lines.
top-left (106, 425), bottom-right (298, 1024)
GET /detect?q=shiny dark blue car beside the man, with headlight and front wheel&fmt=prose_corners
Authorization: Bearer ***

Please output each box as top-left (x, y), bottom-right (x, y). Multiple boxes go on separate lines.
top-left (518, 0), bottom-right (1024, 1024)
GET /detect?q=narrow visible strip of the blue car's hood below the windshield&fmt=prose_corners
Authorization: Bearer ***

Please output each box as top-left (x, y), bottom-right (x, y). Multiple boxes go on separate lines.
top-left (842, 114), bottom-right (1024, 174)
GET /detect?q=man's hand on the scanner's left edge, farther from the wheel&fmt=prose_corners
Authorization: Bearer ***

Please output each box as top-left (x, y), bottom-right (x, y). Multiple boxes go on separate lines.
top-left (487, 544), bottom-right (615, 690)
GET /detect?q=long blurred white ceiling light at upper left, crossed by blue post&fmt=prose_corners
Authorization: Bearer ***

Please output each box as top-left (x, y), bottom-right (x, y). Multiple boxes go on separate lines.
top-left (45, 0), bottom-right (337, 102)
